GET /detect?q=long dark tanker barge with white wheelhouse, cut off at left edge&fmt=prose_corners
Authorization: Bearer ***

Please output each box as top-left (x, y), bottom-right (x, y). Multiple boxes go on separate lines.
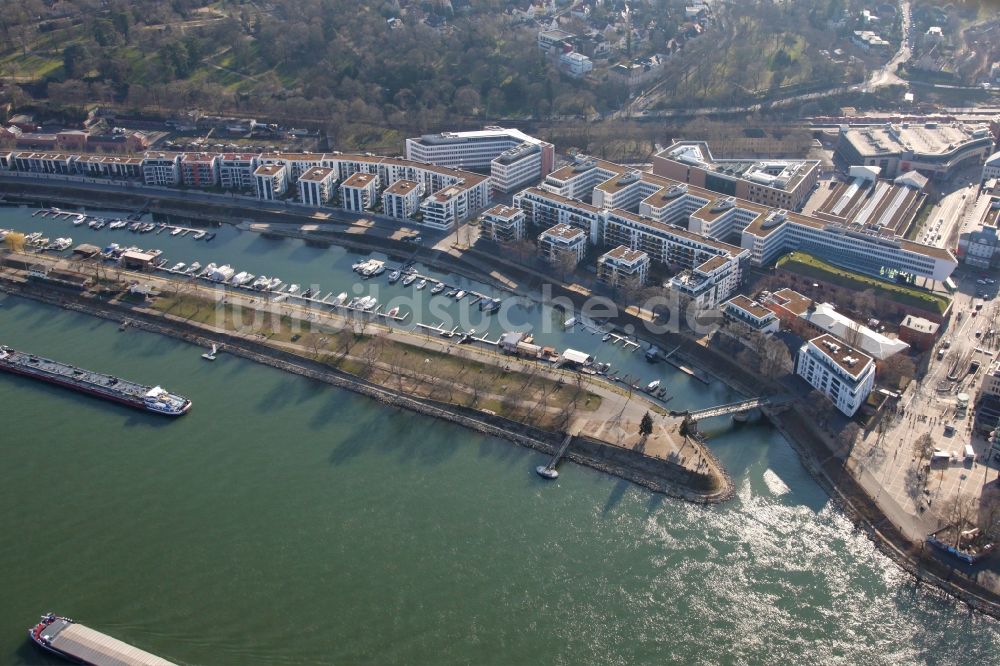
top-left (0, 346), bottom-right (191, 416)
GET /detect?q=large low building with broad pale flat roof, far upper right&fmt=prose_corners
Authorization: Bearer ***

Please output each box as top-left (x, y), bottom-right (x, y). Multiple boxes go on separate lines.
top-left (836, 122), bottom-right (993, 180)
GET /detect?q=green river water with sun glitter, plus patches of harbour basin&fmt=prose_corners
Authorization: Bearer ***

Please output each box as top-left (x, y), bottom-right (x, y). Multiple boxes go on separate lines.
top-left (0, 205), bottom-right (1000, 664)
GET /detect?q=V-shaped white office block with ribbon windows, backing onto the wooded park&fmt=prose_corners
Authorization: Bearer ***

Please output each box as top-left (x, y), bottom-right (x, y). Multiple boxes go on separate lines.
top-left (406, 127), bottom-right (555, 192)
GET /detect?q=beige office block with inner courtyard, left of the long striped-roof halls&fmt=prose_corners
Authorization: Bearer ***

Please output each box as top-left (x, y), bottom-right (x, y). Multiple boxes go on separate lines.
top-left (653, 141), bottom-right (820, 210)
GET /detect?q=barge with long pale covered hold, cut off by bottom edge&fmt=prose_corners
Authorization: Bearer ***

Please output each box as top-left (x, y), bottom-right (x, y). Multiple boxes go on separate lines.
top-left (28, 613), bottom-right (175, 666)
